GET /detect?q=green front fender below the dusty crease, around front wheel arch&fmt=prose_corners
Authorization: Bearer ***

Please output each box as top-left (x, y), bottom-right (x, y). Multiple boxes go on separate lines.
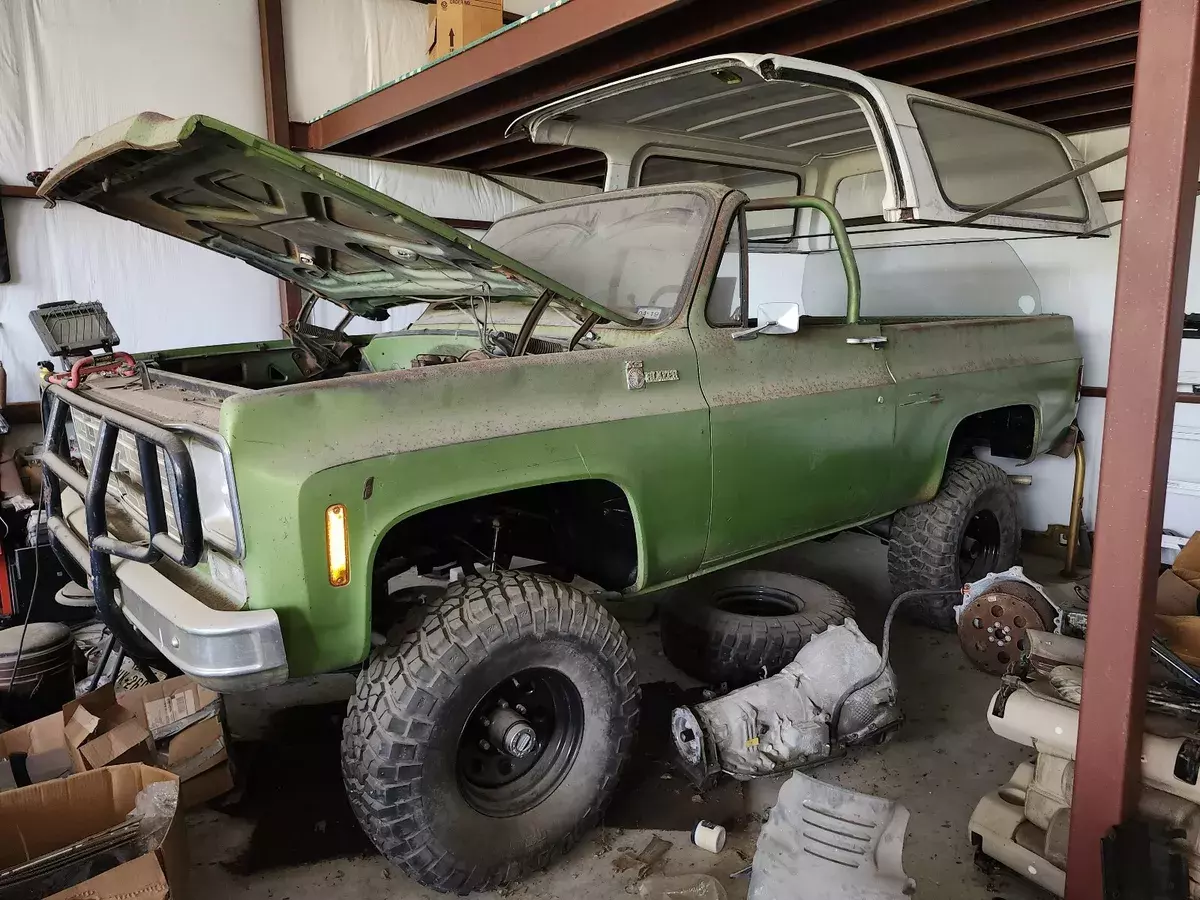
top-left (239, 412), bottom-right (710, 676)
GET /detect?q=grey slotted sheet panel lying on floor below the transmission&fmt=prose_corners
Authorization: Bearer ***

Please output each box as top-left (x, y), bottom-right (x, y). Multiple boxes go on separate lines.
top-left (750, 772), bottom-right (917, 900)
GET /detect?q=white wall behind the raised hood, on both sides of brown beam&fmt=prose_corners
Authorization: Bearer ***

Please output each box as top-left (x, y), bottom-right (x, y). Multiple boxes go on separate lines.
top-left (0, 0), bottom-right (588, 402)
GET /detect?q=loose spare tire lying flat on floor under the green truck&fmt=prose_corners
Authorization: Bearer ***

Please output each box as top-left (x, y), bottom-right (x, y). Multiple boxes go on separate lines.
top-left (661, 570), bottom-right (854, 688)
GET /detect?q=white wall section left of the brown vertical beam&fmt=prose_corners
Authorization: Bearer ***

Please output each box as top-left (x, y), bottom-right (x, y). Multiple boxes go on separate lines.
top-left (0, 0), bottom-right (278, 401)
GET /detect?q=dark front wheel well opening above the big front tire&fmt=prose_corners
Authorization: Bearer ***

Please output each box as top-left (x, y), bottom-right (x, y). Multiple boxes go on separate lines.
top-left (372, 479), bottom-right (637, 619)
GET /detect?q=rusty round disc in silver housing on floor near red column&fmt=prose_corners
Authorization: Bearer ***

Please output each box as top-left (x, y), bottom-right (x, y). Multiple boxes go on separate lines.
top-left (954, 565), bottom-right (1061, 674)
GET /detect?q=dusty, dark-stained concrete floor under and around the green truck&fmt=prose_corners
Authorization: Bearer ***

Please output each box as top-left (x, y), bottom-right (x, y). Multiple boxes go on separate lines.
top-left (188, 534), bottom-right (1049, 900)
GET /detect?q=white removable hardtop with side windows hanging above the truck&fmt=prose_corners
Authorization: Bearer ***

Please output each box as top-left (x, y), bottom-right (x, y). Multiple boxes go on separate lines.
top-left (509, 54), bottom-right (1106, 244)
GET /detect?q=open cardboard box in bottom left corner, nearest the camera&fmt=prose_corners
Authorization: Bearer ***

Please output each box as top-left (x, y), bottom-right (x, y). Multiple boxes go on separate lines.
top-left (0, 764), bottom-right (187, 900)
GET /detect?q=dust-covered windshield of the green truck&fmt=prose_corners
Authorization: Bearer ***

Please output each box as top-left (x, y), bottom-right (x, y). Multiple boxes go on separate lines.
top-left (484, 192), bottom-right (709, 328)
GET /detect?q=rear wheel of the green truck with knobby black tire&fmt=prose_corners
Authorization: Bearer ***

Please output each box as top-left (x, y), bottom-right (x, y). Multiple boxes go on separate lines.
top-left (888, 456), bottom-right (1021, 631)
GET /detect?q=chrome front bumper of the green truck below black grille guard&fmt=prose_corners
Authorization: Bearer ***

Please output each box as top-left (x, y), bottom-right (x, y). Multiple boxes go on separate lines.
top-left (50, 491), bottom-right (288, 692)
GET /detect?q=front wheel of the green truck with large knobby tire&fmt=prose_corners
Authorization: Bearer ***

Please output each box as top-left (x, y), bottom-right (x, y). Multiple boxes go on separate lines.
top-left (342, 572), bottom-right (640, 893)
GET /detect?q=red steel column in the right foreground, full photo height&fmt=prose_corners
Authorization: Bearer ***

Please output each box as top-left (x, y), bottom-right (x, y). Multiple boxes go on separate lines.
top-left (1067, 0), bottom-right (1200, 900)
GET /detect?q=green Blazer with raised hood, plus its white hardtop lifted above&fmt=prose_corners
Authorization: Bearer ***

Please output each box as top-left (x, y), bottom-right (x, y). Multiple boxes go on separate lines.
top-left (40, 54), bottom-right (1104, 893)
